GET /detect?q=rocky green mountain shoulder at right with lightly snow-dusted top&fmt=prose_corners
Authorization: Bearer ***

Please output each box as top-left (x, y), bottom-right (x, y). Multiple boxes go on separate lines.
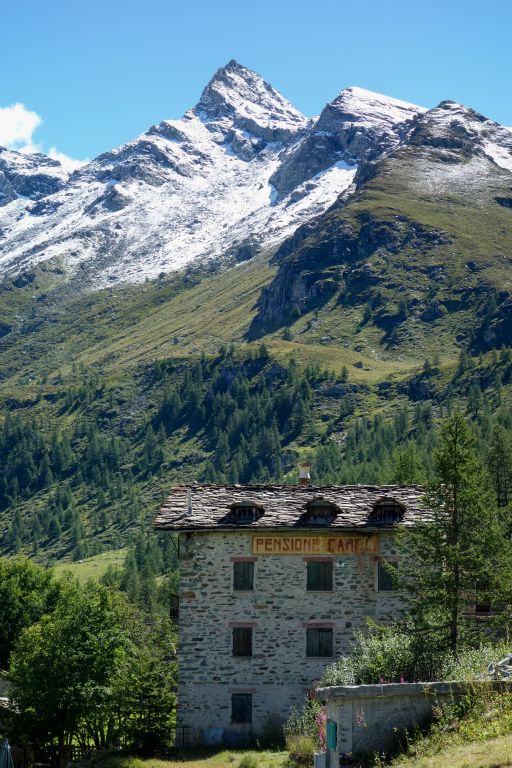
top-left (251, 100), bottom-right (512, 356)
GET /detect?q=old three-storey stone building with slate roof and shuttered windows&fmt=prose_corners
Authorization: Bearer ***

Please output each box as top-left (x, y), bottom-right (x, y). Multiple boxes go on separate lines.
top-left (155, 480), bottom-right (425, 744)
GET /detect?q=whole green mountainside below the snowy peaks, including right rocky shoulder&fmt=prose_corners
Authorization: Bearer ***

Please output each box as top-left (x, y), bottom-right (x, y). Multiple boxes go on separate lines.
top-left (0, 105), bottom-right (512, 560)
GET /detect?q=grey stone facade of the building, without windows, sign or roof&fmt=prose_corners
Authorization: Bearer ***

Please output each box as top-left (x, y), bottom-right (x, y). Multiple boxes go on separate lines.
top-left (178, 531), bottom-right (401, 742)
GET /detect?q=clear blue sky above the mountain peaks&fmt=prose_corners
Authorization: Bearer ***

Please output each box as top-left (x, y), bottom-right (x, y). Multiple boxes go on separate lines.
top-left (0, 0), bottom-right (512, 164)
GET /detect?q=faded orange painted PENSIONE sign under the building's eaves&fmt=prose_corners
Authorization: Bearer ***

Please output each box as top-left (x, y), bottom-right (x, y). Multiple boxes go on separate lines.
top-left (252, 534), bottom-right (379, 555)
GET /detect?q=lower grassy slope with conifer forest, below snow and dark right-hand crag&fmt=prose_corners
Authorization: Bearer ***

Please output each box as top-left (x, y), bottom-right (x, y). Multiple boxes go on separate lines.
top-left (0, 252), bottom-right (512, 561)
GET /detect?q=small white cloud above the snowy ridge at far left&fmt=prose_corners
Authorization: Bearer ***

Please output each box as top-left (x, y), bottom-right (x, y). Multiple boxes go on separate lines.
top-left (0, 103), bottom-right (87, 172)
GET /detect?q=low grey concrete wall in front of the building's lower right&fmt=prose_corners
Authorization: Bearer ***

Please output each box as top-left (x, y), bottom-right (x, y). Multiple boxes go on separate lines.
top-left (317, 682), bottom-right (484, 768)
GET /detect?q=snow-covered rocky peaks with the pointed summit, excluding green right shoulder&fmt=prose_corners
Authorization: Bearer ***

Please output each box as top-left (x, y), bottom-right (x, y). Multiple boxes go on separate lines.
top-left (0, 61), bottom-right (432, 289)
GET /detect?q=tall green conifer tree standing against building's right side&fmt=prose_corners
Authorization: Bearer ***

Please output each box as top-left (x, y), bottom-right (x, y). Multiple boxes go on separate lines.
top-left (398, 411), bottom-right (510, 652)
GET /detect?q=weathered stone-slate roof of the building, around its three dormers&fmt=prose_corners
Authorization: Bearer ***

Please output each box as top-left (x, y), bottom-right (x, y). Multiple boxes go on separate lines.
top-left (155, 485), bottom-right (429, 531)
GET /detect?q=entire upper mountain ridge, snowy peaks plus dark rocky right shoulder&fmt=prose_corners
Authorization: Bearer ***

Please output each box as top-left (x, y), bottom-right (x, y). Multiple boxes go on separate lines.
top-left (0, 61), bottom-right (512, 364)
